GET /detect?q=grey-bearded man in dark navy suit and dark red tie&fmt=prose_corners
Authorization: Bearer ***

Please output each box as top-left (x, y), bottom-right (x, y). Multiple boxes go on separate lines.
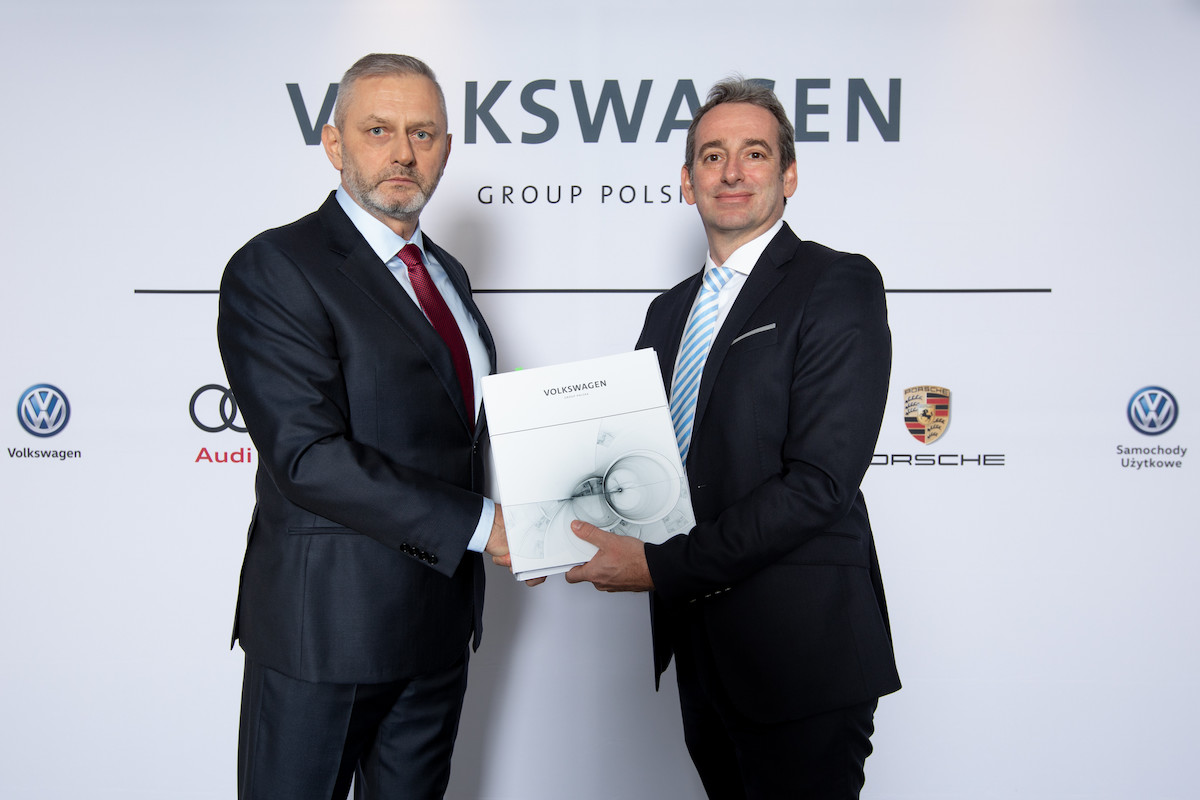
top-left (217, 54), bottom-right (508, 800)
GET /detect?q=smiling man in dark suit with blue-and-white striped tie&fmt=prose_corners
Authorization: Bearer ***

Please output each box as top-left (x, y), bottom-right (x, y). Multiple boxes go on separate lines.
top-left (566, 80), bottom-right (900, 800)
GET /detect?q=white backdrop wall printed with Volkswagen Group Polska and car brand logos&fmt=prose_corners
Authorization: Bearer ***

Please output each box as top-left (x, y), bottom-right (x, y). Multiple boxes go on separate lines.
top-left (0, 0), bottom-right (1200, 800)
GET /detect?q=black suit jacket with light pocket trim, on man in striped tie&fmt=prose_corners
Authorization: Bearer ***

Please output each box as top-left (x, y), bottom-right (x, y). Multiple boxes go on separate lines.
top-left (638, 224), bottom-right (900, 722)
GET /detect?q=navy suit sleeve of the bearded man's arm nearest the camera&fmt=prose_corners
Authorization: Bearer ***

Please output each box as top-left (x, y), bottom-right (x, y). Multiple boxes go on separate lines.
top-left (217, 239), bottom-right (484, 575)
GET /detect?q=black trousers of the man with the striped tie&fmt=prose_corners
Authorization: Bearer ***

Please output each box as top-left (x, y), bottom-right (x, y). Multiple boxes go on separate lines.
top-left (676, 619), bottom-right (878, 800)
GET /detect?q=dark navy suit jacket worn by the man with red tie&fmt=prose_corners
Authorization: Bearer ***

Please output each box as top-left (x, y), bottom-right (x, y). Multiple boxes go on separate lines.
top-left (217, 194), bottom-right (496, 682)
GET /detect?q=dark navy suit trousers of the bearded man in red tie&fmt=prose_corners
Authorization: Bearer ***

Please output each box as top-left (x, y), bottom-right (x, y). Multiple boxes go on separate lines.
top-left (238, 652), bottom-right (467, 800)
